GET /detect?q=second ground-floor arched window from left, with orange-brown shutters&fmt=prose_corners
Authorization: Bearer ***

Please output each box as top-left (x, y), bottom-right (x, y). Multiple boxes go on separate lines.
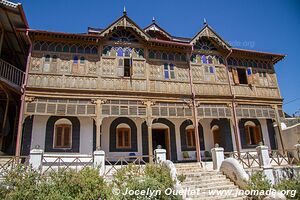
top-left (116, 123), bottom-right (131, 149)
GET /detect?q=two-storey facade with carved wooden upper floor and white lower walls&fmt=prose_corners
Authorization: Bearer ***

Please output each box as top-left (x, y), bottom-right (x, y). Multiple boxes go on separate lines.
top-left (21, 12), bottom-right (284, 161)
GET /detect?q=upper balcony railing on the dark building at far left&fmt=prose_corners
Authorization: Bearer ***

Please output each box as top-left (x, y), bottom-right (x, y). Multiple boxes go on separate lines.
top-left (0, 59), bottom-right (25, 87)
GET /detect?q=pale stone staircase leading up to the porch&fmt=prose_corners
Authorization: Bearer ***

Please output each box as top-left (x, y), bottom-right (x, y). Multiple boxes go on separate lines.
top-left (175, 163), bottom-right (245, 200)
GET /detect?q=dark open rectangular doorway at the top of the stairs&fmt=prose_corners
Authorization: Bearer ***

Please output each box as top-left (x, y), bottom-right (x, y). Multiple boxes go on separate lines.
top-left (152, 129), bottom-right (170, 160)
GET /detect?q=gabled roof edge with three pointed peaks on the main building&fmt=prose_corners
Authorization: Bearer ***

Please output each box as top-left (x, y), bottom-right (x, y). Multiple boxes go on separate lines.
top-left (24, 12), bottom-right (285, 63)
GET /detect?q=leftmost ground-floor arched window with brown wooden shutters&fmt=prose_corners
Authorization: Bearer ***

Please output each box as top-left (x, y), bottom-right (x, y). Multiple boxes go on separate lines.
top-left (53, 118), bottom-right (72, 149)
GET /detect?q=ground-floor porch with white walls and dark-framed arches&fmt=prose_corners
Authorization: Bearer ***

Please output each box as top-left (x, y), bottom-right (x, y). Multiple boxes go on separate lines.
top-left (22, 115), bottom-right (279, 162)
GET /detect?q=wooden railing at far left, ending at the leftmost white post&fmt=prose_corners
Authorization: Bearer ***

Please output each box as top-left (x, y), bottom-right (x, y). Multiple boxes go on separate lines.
top-left (0, 156), bottom-right (29, 177)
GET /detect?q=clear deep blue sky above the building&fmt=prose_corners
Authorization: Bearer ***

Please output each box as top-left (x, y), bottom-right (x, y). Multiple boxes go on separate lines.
top-left (15, 0), bottom-right (300, 115)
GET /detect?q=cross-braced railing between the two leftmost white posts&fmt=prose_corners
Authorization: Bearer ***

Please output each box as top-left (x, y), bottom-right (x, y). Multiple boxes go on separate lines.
top-left (41, 155), bottom-right (93, 174)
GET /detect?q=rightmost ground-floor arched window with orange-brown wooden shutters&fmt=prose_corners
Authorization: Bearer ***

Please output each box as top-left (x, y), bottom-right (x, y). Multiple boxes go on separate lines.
top-left (244, 121), bottom-right (262, 146)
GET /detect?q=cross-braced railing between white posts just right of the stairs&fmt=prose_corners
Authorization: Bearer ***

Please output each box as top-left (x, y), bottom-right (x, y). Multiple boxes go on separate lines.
top-left (224, 151), bottom-right (259, 168)
